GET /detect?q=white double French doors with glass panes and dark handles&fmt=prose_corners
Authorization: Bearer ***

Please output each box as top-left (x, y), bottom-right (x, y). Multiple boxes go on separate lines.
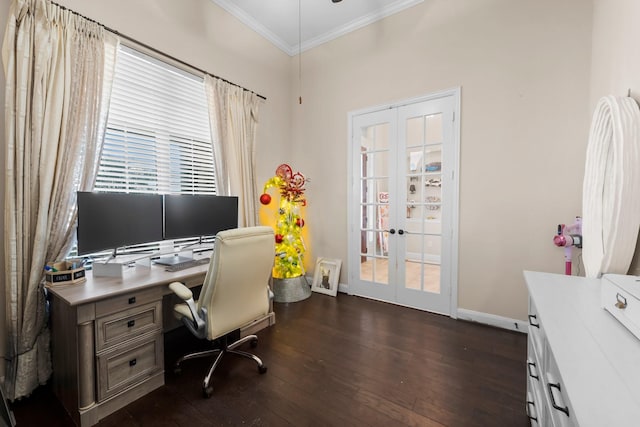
top-left (349, 90), bottom-right (459, 315)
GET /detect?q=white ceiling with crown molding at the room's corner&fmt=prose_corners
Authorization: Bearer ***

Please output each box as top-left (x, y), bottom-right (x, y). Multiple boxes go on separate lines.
top-left (212, 0), bottom-right (423, 56)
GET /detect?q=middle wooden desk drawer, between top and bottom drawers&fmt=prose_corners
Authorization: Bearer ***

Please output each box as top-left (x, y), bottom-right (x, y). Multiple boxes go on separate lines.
top-left (96, 301), bottom-right (162, 352)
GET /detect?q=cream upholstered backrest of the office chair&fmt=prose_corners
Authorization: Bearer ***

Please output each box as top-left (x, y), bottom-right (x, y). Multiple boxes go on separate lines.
top-left (198, 226), bottom-right (275, 340)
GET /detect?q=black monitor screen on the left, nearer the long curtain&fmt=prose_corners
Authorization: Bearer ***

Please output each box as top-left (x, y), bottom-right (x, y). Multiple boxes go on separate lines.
top-left (78, 192), bottom-right (162, 255)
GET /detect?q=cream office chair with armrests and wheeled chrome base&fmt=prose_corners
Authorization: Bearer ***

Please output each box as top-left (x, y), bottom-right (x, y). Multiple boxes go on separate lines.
top-left (169, 226), bottom-right (275, 397)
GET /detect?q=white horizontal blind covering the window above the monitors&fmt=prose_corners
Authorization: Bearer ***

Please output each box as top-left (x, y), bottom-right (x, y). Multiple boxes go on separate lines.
top-left (94, 46), bottom-right (216, 194)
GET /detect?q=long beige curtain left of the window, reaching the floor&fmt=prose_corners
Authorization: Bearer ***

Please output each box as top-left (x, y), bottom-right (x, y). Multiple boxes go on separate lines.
top-left (2, 0), bottom-right (117, 399)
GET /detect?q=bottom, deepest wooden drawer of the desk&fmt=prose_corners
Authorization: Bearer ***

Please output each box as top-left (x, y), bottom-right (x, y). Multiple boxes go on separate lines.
top-left (97, 333), bottom-right (164, 402)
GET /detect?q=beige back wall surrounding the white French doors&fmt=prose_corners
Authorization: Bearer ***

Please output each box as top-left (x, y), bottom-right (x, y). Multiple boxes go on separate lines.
top-left (292, 0), bottom-right (596, 319)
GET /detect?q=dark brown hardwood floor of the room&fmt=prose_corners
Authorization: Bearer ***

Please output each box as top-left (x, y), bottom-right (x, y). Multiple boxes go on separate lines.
top-left (12, 294), bottom-right (528, 427)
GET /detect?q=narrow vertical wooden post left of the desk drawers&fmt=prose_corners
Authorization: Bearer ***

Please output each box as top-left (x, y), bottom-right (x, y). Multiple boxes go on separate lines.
top-left (78, 321), bottom-right (96, 410)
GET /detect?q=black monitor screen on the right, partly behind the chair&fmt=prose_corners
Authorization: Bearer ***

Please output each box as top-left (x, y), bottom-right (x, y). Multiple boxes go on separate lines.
top-left (164, 194), bottom-right (238, 239)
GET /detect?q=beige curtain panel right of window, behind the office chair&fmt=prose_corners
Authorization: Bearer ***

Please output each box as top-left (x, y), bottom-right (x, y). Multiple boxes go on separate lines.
top-left (204, 76), bottom-right (260, 227)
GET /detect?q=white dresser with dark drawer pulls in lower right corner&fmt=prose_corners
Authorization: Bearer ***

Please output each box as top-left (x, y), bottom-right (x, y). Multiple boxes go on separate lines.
top-left (524, 271), bottom-right (640, 427)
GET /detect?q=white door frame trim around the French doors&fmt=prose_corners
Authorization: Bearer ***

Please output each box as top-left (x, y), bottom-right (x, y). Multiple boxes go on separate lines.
top-left (347, 86), bottom-right (461, 319)
